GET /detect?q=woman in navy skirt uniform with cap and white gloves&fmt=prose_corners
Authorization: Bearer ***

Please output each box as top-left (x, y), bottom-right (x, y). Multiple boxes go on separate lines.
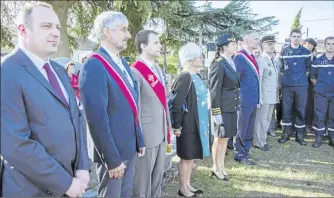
top-left (209, 34), bottom-right (240, 181)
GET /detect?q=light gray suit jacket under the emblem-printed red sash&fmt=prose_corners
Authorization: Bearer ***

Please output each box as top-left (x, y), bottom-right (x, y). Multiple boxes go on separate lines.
top-left (131, 61), bottom-right (171, 148)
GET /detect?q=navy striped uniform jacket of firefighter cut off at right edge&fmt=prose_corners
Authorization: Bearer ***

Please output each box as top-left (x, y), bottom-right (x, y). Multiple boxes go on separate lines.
top-left (311, 54), bottom-right (334, 97)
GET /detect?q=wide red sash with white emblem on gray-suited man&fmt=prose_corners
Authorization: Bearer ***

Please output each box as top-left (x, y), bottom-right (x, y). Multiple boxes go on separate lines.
top-left (131, 60), bottom-right (171, 144)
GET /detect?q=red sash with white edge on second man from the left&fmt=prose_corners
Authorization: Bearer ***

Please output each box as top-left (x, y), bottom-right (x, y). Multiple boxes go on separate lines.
top-left (91, 53), bottom-right (139, 128)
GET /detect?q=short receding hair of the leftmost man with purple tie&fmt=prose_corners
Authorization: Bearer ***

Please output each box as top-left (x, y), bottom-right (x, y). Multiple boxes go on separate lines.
top-left (16, 1), bottom-right (53, 29)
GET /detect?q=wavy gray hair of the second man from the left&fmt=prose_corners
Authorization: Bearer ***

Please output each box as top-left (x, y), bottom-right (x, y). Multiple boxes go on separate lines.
top-left (94, 11), bottom-right (129, 40)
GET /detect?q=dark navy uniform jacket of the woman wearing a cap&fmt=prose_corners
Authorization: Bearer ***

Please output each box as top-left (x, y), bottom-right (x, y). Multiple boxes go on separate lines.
top-left (209, 57), bottom-right (240, 115)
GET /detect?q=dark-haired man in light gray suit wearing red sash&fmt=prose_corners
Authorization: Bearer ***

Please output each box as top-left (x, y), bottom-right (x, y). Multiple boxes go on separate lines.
top-left (131, 30), bottom-right (171, 197)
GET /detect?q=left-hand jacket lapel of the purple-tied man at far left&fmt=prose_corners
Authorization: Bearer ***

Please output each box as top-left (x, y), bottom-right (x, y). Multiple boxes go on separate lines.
top-left (15, 48), bottom-right (67, 106)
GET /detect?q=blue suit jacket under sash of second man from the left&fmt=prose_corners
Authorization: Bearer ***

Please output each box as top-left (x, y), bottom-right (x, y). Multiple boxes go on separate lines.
top-left (79, 47), bottom-right (144, 169)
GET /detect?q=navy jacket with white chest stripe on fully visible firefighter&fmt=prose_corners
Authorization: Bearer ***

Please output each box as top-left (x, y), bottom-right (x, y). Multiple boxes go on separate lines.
top-left (280, 45), bottom-right (312, 87)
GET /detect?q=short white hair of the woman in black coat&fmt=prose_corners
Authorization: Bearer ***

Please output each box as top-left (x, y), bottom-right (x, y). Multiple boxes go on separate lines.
top-left (179, 42), bottom-right (202, 65)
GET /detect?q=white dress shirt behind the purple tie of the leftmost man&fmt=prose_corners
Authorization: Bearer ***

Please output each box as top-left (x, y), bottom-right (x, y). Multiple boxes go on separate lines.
top-left (20, 46), bottom-right (69, 104)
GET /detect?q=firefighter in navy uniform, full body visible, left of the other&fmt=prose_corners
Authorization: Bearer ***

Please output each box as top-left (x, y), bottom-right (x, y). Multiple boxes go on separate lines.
top-left (278, 29), bottom-right (312, 146)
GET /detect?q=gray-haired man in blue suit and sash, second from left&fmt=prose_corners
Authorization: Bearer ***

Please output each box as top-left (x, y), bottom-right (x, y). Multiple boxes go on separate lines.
top-left (79, 12), bottom-right (145, 197)
